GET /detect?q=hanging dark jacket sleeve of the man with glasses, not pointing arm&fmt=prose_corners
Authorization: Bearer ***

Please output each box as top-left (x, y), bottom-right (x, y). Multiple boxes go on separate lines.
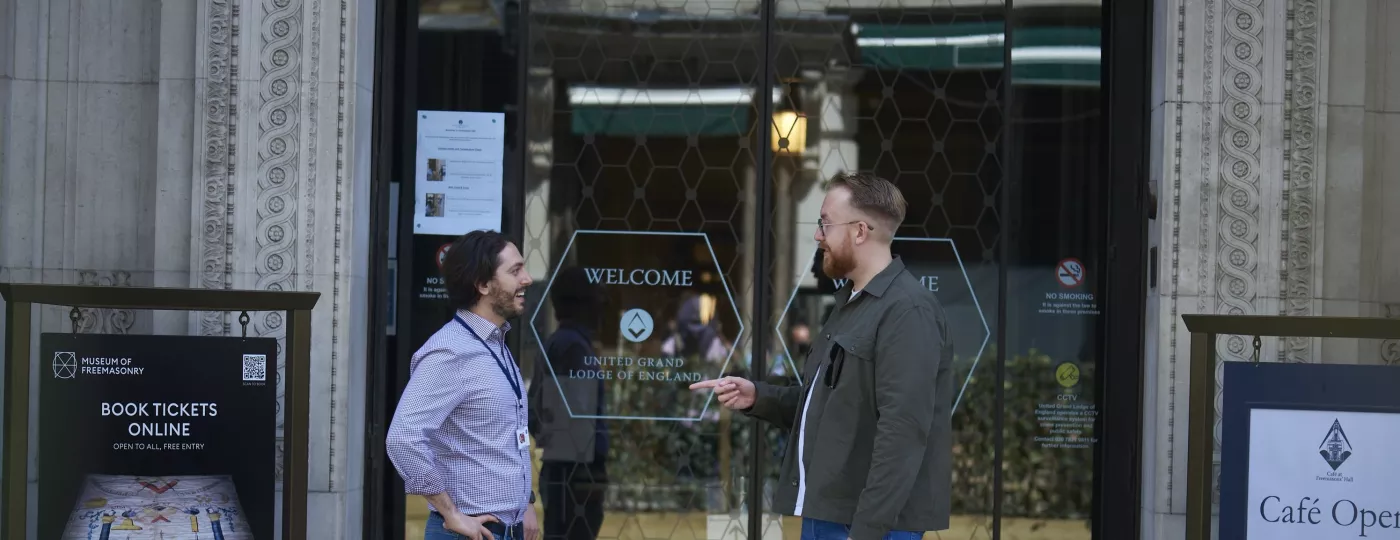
top-left (850, 305), bottom-right (946, 540)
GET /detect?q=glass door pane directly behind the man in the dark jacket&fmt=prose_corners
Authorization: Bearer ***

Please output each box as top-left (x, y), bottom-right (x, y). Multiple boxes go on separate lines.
top-left (764, 0), bottom-right (1004, 539)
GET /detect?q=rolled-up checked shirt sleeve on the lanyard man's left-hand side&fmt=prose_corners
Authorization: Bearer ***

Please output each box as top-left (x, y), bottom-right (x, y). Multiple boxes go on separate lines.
top-left (385, 350), bottom-right (468, 495)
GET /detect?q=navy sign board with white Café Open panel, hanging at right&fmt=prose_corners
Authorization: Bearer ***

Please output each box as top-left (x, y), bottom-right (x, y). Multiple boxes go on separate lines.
top-left (1218, 362), bottom-right (1400, 540)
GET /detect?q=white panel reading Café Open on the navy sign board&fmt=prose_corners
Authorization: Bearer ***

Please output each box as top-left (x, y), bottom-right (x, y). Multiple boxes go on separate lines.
top-left (1248, 408), bottom-right (1400, 540)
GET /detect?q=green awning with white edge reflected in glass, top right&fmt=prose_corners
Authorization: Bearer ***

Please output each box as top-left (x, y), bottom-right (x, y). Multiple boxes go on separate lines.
top-left (855, 22), bottom-right (1103, 85)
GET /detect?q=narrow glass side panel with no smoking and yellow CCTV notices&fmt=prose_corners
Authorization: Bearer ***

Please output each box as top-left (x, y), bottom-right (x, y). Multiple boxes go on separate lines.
top-left (1002, 3), bottom-right (1107, 539)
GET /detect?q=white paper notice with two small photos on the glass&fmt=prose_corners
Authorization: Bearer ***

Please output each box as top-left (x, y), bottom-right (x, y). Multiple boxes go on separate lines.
top-left (413, 111), bottom-right (505, 236)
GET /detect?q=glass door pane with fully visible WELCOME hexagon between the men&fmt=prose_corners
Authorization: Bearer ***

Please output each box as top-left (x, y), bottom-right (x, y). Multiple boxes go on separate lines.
top-left (522, 0), bottom-right (766, 540)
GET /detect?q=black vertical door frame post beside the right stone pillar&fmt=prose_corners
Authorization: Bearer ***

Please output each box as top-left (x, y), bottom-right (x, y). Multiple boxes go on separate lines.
top-left (1092, 0), bottom-right (1156, 539)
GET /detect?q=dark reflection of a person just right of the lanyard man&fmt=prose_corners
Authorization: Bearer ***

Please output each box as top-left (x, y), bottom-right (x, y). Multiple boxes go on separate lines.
top-left (532, 267), bottom-right (609, 540)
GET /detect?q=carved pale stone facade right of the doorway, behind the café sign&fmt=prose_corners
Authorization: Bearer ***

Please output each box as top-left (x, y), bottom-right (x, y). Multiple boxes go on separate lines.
top-left (1142, 0), bottom-right (1400, 539)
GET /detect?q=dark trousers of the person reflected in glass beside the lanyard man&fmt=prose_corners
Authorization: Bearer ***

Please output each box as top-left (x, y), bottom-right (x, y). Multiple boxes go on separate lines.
top-left (539, 459), bottom-right (608, 540)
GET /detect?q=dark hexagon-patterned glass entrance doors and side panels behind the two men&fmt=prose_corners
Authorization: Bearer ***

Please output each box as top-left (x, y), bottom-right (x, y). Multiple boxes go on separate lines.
top-left (386, 0), bottom-right (1135, 540)
